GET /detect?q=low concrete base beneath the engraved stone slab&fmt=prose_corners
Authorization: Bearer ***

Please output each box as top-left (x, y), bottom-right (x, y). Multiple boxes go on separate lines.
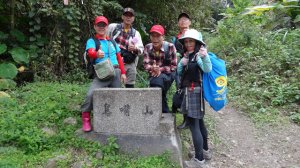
top-left (77, 114), bottom-right (182, 167)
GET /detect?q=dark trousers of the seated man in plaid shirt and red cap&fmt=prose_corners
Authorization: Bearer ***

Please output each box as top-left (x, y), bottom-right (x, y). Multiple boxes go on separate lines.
top-left (150, 72), bottom-right (175, 113)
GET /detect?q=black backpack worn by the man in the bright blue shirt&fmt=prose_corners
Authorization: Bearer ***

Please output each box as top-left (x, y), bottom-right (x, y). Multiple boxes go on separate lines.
top-left (82, 37), bottom-right (117, 79)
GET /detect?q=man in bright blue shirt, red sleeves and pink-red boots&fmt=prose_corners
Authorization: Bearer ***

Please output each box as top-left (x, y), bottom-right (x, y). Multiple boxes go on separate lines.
top-left (81, 16), bottom-right (126, 132)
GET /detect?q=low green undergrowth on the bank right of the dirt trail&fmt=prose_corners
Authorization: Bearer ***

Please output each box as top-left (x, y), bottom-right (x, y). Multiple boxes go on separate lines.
top-left (209, 4), bottom-right (300, 122)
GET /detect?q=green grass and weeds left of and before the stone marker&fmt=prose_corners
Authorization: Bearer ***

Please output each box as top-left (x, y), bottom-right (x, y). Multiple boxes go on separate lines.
top-left (0, 82), bottom-right (179, 168)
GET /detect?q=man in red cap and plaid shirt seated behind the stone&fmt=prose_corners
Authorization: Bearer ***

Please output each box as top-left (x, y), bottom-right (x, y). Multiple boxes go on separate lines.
top-left (143, 25), bottom-right (177, 113)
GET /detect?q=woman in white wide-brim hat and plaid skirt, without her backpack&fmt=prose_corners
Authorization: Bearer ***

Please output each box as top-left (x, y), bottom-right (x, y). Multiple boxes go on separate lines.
top-left (177, 29), bottom-right (212, 167)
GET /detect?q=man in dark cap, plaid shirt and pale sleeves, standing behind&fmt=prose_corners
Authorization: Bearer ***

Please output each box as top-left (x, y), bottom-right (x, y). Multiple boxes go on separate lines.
top-left (108, 8), bottom-right (144, 88)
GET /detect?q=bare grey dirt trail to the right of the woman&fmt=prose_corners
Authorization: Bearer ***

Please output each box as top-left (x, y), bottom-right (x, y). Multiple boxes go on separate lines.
top-left (207, 106), bottom-right (300, 168)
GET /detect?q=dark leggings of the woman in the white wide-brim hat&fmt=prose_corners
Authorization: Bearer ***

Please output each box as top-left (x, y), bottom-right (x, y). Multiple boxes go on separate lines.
top-left (187, 117), bottom-right (208, 161)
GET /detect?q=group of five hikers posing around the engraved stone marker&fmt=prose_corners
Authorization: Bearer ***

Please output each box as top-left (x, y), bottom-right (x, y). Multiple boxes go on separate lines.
top-left (81, 8), bottom-right (212, 167)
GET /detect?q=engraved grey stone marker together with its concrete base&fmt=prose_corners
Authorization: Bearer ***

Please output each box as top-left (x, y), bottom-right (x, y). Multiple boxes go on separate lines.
top-left (78, 88), bottom-right (182, 166)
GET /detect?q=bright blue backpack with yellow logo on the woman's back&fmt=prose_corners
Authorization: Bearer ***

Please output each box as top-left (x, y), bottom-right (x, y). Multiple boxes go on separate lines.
top-left (203, 52), bottom-right (227, 111)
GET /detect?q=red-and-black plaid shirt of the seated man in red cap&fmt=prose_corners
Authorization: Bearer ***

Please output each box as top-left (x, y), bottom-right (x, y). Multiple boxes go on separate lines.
top-left (143, 41), bottom-right (177, 74)
